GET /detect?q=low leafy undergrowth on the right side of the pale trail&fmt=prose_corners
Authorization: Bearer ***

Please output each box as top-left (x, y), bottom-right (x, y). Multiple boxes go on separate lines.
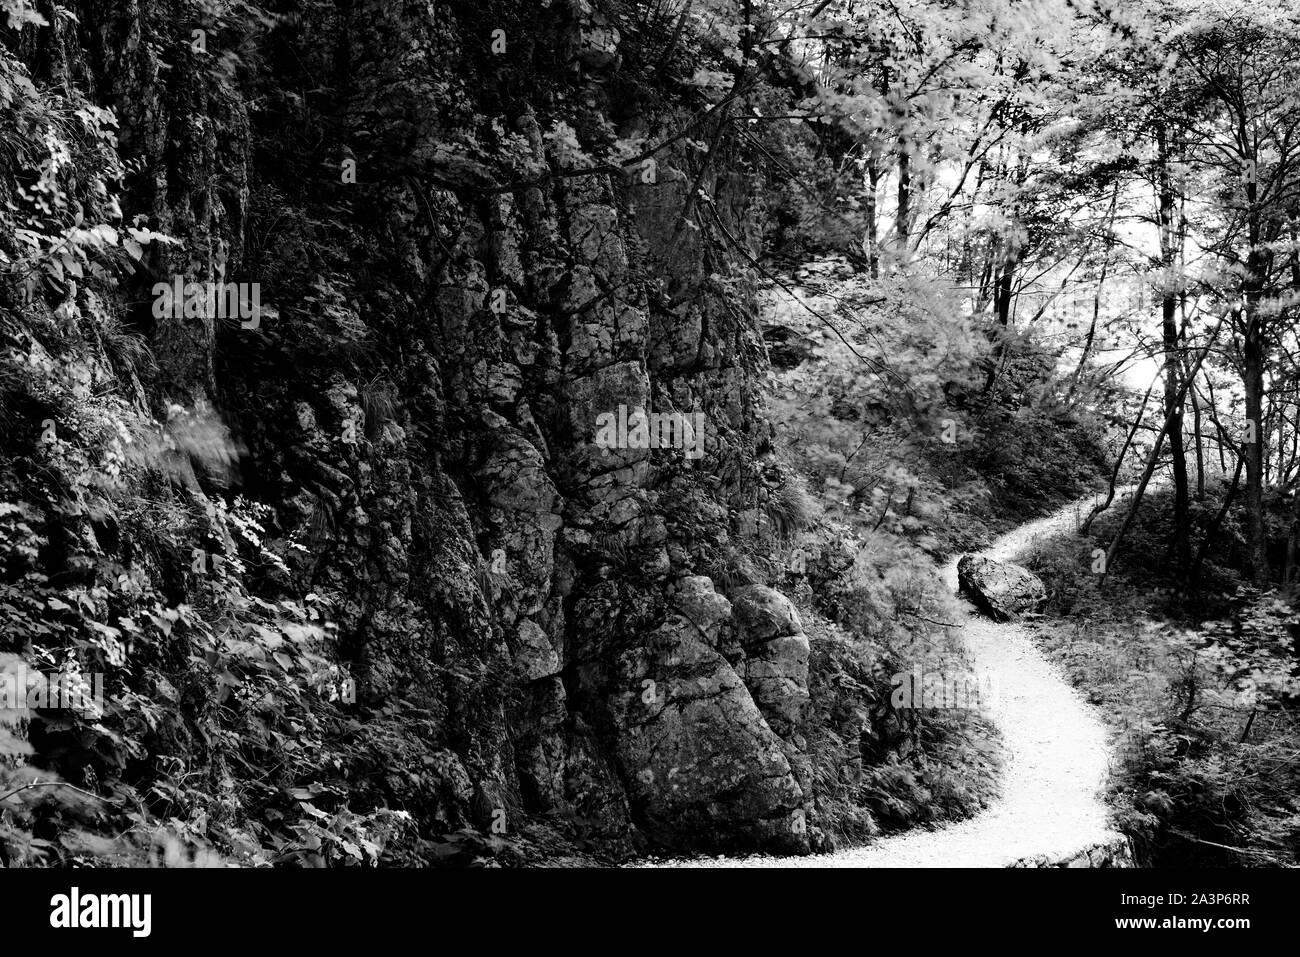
top-left (1026, 489), bottom-right (1300, 867)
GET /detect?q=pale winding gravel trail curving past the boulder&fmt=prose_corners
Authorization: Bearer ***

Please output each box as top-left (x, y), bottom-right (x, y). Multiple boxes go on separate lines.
top-left (673, 493), bottom-right (1123, 867)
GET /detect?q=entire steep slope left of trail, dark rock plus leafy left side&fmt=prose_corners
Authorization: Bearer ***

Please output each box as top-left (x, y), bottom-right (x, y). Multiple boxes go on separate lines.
top-left (0, 0), bottom-right (842, 859)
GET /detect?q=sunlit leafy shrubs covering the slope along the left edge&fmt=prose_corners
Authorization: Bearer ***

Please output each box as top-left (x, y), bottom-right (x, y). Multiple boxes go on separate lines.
top-left (0, 33), bottom-right (410, 866)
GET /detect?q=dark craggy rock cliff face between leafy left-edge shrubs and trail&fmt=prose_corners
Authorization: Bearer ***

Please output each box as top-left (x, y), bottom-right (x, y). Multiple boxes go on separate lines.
top-left (0, 0), bottom-right (811, 852)
